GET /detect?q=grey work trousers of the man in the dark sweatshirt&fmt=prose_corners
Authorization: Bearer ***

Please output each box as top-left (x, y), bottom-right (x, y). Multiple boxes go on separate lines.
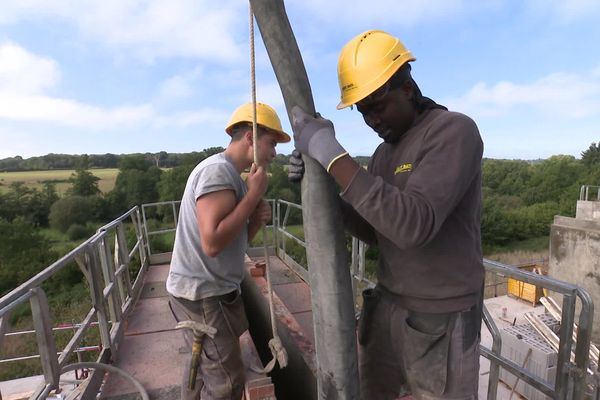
top-left (359, 288), bottom-right (481, 400)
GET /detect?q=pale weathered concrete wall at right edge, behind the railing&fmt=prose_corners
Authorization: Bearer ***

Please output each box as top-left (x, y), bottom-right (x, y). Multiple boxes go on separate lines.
top-left (548, 214), bottom-right (600, 343)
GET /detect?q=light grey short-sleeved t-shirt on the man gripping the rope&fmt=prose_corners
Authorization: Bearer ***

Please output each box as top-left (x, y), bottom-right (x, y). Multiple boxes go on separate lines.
top-left (167, 153), bottom-right (248, 301)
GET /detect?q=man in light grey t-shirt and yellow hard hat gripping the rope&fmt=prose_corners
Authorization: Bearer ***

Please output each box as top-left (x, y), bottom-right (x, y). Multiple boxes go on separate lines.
top-left (167, 103), bottom-right (290, 400)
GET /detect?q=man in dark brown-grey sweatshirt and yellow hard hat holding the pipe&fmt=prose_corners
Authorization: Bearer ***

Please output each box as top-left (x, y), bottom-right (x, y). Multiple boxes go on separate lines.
top-left (291, 31), bottom-right (484, 400)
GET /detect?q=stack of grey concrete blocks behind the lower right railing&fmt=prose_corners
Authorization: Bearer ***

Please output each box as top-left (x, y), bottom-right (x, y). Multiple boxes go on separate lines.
top-left (500, 314), bottom-right (559, 400)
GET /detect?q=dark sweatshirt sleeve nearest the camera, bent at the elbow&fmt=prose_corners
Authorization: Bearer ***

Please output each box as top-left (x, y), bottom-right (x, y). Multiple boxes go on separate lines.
top-left (342, 113), bottom-right (483, 249)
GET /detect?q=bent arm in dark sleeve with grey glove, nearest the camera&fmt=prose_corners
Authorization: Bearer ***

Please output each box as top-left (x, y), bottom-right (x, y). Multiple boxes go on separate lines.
top-left (292, 106), bottom-right (483, 248)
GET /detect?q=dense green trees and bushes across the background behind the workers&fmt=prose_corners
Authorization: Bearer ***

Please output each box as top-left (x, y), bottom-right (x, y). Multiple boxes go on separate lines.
top-left (0, 143), bottom-right (600, 294)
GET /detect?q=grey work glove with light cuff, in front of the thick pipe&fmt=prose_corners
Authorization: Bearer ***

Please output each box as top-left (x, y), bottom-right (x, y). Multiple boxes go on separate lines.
top-left (292, 106), bottom-right (348, 172)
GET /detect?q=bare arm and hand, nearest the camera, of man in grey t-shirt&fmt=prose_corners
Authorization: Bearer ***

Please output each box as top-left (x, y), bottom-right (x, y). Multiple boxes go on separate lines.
top-left (196, 166), bottom-right (267, 257)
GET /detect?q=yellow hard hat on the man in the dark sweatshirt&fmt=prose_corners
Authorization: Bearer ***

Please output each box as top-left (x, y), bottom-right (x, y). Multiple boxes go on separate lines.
top-left (337, 30), bottom-right (416, 110)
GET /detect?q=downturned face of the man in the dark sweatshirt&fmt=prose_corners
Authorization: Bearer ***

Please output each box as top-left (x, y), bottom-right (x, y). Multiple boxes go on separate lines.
top-left (356, 82), bottom-right (415, 143)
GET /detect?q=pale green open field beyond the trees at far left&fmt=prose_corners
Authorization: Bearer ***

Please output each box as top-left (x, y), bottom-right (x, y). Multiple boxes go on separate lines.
top-left (0, 168), bottom-right (119, 194)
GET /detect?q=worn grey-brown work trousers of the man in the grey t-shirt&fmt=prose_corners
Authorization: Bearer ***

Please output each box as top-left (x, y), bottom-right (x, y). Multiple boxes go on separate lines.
top-left (169, 291), bottom-right (248, 400)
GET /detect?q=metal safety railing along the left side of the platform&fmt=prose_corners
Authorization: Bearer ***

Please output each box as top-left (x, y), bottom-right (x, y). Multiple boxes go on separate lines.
top-left (0, 207), bottom-right (148, 400)
